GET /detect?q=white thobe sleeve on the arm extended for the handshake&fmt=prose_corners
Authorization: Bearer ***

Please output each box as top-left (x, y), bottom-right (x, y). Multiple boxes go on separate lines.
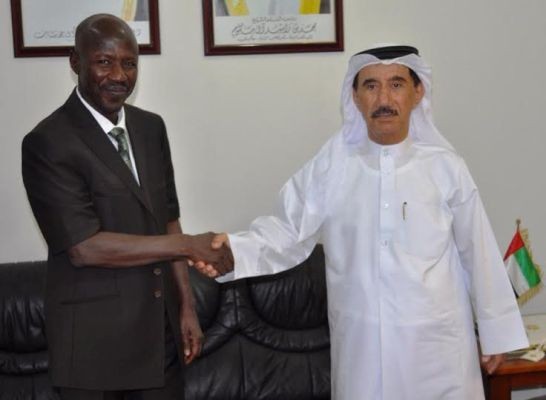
top-left (224, 133), bottom-right (347, 280)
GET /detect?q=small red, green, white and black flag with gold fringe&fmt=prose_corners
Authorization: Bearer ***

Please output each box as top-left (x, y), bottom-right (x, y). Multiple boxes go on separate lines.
top-left (504, 228), bottom-right (542, 304)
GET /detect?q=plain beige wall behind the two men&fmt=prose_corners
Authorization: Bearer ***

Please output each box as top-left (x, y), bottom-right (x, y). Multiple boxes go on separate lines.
top-left (0, 0), bottom-right (546, 312)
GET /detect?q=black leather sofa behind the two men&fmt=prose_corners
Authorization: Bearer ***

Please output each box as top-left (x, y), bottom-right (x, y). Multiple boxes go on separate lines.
top-left (0, 246), bottom-right (330, 400)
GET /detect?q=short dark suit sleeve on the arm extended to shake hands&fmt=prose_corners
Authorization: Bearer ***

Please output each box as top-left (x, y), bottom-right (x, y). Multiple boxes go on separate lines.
top-left (22, 132), bottom-right (100, 254)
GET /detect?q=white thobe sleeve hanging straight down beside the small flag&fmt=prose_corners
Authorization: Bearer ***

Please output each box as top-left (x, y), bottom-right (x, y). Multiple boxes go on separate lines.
top-left (450, 162), bottom-right (528, 354)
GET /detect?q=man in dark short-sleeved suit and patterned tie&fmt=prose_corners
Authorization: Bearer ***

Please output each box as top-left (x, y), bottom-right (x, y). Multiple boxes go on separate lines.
top-left (23, 14), bottom-right (228, 400)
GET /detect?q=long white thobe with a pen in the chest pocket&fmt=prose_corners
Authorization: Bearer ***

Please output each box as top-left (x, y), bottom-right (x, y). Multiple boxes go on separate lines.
top-left (229, 135), bottom-right (528, 400)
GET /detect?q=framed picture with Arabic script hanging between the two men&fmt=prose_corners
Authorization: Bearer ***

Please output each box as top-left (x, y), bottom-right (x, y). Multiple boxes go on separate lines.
top-left (202, 0), bottom-right (343, 55)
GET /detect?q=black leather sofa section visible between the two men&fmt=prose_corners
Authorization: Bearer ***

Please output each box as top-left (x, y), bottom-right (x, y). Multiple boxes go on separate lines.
top-left (186, 246), bottom-right (330, 400)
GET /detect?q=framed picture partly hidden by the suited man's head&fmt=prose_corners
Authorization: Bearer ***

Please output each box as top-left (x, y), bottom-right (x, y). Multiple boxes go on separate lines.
top-left (11, 0), bottom-right (161, 57)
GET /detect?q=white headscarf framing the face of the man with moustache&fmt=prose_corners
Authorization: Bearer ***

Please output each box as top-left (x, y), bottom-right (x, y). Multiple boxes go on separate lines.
top-left (341, 48), bottom-right (453, 150)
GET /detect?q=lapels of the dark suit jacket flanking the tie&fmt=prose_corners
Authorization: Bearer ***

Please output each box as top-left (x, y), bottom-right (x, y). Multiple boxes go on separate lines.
top-left (65, 91), bottom-right (155, 219)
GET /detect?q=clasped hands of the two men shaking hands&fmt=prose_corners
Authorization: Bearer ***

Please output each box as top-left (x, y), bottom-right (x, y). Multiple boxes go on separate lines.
top-left (182, 232), bottom-right (234, 278)
